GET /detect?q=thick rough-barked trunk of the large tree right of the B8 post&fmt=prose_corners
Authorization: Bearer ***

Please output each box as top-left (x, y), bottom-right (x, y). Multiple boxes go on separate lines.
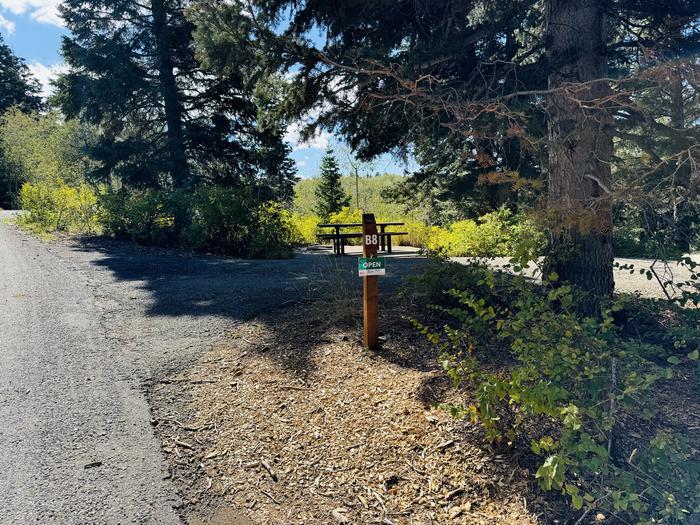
top-left (546, 0), bottom-right (614, 315)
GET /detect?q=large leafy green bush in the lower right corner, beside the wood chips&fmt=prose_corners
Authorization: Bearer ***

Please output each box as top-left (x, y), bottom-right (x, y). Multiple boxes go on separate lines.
top-left (415, 260), bottom-right (700, 524)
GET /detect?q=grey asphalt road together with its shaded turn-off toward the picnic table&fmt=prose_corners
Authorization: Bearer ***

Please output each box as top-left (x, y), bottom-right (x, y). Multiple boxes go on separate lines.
top-left (0, 213), bottom-right (415, 525)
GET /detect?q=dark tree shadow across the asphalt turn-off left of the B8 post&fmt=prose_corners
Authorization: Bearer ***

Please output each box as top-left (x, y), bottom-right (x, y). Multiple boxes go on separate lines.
top-left (74, 238), bottom-right (420, 320)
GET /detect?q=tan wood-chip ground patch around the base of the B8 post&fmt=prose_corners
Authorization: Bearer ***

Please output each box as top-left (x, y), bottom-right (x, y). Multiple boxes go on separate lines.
top-left (153, 298), bottom-right (548, 525)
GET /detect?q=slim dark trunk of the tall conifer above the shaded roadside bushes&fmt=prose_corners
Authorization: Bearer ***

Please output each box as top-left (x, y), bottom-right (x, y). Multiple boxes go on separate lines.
top-left (151, 0), bottom-right (190, 187)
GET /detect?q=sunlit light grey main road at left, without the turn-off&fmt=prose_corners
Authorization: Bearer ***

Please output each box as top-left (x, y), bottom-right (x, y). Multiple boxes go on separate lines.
top-left (0, 219), bottom-right (179, 524)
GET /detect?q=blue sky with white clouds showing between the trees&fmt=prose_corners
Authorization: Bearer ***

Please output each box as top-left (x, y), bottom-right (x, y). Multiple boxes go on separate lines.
top-left (0, 0), bottom-right (406, 178)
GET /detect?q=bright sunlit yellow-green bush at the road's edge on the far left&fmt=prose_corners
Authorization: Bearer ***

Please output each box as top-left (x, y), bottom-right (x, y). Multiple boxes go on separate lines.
top-left (20, 180), bottom-right (99, 233)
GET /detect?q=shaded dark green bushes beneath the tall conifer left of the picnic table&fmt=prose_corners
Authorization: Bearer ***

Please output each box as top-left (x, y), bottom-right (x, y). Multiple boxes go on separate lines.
top-left (102, 186), bottom-right (300, 258)
